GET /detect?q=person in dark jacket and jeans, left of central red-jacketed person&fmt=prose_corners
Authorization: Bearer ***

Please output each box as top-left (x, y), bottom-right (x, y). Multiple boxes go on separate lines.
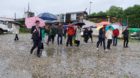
top-left (57, 24), bottom-right (64, 45)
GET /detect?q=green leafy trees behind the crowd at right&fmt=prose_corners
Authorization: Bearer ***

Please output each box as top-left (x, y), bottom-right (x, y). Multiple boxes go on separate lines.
top-left (90, 5), bottom-right (140, 27)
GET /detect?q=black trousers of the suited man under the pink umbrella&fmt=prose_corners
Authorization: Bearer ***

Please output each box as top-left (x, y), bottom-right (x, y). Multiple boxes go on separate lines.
top-left (31, 39), bottom-right (42, 56)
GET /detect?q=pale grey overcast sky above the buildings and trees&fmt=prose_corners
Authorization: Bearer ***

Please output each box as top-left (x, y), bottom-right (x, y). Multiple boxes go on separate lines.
top-left (0, 0), bottom-right (140, 17)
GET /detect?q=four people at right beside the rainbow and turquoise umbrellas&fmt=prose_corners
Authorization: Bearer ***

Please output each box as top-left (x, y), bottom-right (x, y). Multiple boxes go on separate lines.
top-left (97, 26), bottom-right (129, 51)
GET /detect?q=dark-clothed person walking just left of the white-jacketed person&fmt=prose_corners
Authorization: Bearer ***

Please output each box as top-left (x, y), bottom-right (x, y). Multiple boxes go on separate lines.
top-left (97, 28), bottom-right (106, 50)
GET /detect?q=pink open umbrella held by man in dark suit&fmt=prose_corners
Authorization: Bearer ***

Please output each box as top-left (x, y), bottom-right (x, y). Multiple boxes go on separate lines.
top-left (25, 17), bottom-right (45, 28)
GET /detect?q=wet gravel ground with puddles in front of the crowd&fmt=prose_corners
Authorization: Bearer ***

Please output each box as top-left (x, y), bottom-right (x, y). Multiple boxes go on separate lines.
top-left (0, 34), bottom-right (140, 78)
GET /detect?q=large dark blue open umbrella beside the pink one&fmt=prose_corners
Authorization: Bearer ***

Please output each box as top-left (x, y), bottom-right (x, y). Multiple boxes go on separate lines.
top-left (38, 13), bottom-right (57, 21)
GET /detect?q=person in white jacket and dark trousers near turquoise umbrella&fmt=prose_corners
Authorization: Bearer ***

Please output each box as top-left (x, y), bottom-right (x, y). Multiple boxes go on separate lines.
top-left (106, 27), bottom-right (113, 50)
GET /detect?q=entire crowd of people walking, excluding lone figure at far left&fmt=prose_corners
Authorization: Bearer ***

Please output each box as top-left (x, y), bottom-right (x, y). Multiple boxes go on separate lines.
top-left (30, 21), bottom-right (129, 57)
